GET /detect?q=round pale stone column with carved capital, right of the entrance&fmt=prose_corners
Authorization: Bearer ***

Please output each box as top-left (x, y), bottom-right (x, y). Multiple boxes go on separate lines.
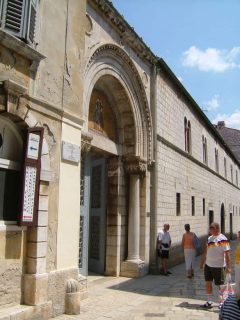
top-left (121, 157), bottom-right (148, 278)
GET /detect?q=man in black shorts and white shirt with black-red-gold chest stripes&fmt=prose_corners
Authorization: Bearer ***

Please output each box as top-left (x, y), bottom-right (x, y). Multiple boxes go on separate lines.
top-left (200, 222), bottom-right (231, 309)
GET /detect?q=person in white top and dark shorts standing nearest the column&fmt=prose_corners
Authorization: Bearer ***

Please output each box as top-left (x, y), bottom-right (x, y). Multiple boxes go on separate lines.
top-left (157, 223), bottom-right (172, 276)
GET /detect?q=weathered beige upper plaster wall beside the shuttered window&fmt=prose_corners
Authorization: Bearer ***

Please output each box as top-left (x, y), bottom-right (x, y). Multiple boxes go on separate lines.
top-left (34, 0), bottom-right (86, 116)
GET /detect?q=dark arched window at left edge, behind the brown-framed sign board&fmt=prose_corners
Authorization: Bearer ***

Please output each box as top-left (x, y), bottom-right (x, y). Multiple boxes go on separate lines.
top-left (0, 116), bottom-right (23, 222)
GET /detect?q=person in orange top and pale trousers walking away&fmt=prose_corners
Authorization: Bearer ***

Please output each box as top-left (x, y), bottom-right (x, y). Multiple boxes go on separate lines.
top-left (182, 223), bottom-right (196, 279)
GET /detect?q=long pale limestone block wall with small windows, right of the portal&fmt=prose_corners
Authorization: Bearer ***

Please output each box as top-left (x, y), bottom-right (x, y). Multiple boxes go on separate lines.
top-left (156, 72), bottom-right (240, 255)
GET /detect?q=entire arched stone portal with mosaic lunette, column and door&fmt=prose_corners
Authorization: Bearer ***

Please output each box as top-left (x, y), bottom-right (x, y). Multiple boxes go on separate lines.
top-left (79, 45), bottom-right (152, 275)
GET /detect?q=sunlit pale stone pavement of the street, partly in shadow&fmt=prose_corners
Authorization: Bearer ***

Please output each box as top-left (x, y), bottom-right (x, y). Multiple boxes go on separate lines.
top-left (55, 241), bottom-right (236, 320)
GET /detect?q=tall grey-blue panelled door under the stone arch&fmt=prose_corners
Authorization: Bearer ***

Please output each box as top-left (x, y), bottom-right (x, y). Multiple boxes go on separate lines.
top-left (79, 154), bottom-right (107, 276)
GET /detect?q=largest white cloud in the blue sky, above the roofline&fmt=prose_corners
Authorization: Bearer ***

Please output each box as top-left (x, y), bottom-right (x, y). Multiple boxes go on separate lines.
top-left (182, 46), bottom-right (240, 72)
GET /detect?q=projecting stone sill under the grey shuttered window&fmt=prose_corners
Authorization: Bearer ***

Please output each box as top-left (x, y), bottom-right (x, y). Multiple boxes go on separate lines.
top-left (0, 29), bottom-right (45, 63)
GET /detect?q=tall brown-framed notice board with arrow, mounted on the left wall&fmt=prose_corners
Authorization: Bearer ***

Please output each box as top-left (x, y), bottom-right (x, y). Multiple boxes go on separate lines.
top-left (18, 127), bottom-right (43, 226)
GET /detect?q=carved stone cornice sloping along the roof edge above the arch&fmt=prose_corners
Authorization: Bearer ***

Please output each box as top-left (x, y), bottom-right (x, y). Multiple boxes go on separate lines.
top-left (88, 0), bottom-right (158, 65)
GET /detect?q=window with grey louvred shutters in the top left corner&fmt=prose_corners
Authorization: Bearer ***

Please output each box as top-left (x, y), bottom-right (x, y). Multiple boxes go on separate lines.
top-left (0, 0), bottom-right (39, 43)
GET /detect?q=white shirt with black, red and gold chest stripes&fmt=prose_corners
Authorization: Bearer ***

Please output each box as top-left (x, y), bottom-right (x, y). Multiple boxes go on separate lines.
top-left (206, 233), bottom-right (230, 268)
